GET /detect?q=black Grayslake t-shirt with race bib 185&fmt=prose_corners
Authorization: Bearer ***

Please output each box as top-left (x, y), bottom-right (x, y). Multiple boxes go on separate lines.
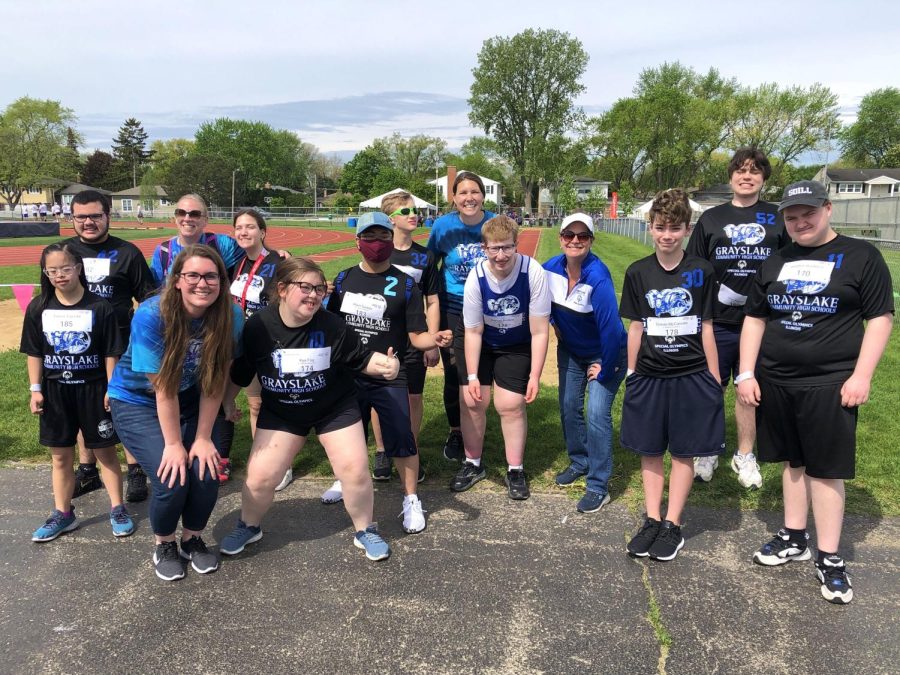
top-left (19, 291), bottom-right (125, 384)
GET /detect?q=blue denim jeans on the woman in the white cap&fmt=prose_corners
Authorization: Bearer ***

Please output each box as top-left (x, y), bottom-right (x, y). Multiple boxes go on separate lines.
top-left (556, 342), bottom-right (627, 495)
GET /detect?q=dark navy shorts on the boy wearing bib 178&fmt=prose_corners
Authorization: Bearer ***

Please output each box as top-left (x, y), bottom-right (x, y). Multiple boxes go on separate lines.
top-left (621, 369), bottom-right (725, 458)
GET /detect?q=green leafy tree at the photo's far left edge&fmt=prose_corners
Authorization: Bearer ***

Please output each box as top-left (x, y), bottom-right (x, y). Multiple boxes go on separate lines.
top-left (0, 96), bottom-right (81, 208)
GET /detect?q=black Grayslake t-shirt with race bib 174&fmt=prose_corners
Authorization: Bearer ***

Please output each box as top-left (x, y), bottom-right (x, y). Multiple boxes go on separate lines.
top-left (231, 305), bottom-right (371, 425)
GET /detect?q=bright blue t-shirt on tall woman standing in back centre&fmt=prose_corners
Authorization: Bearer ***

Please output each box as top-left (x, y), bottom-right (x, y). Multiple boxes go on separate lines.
top-left (427, 211), bottom-right (494, 314)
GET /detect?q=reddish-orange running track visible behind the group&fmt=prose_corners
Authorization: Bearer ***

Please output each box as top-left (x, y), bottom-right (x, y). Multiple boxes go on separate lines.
top-left (0, 223), bottom-right (541, 265)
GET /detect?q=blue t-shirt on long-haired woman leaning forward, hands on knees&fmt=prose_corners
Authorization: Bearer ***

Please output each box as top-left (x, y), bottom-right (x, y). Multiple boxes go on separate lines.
top-left (107, 296), bottom-right (244, 408)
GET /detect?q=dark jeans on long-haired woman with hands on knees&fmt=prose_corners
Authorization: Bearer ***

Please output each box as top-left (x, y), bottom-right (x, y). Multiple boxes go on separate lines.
top-left (109, 389), bottom-right (219, 537)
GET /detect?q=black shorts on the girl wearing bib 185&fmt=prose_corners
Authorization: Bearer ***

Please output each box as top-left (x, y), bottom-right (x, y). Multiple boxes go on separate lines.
top-left (40, 380), bottom-right (119, 450)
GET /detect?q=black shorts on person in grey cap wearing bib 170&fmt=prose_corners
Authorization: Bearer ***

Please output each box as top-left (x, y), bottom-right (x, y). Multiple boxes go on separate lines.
top-left (756, 378), bottom-right (858, 479)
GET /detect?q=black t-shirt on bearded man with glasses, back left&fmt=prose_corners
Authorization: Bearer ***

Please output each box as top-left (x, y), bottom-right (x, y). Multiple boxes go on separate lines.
top-left (63, 236), bottom-right (156, 336)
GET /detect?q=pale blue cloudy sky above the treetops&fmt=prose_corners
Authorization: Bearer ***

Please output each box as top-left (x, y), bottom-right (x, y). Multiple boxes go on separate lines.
top-left (7, 0), bottom-right (900, 156)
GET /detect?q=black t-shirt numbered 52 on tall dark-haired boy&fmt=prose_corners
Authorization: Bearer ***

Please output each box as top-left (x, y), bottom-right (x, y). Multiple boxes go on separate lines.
top-left (685, 202), bottom-right (790, 326)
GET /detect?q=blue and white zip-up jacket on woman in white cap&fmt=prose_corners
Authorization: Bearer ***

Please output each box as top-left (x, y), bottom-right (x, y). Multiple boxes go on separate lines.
top-left (544, 253), bottom-right (627, 382)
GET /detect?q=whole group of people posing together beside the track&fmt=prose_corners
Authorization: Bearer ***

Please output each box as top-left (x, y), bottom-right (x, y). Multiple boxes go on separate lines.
top-left (22, 153), bottom-right (893, 603)
